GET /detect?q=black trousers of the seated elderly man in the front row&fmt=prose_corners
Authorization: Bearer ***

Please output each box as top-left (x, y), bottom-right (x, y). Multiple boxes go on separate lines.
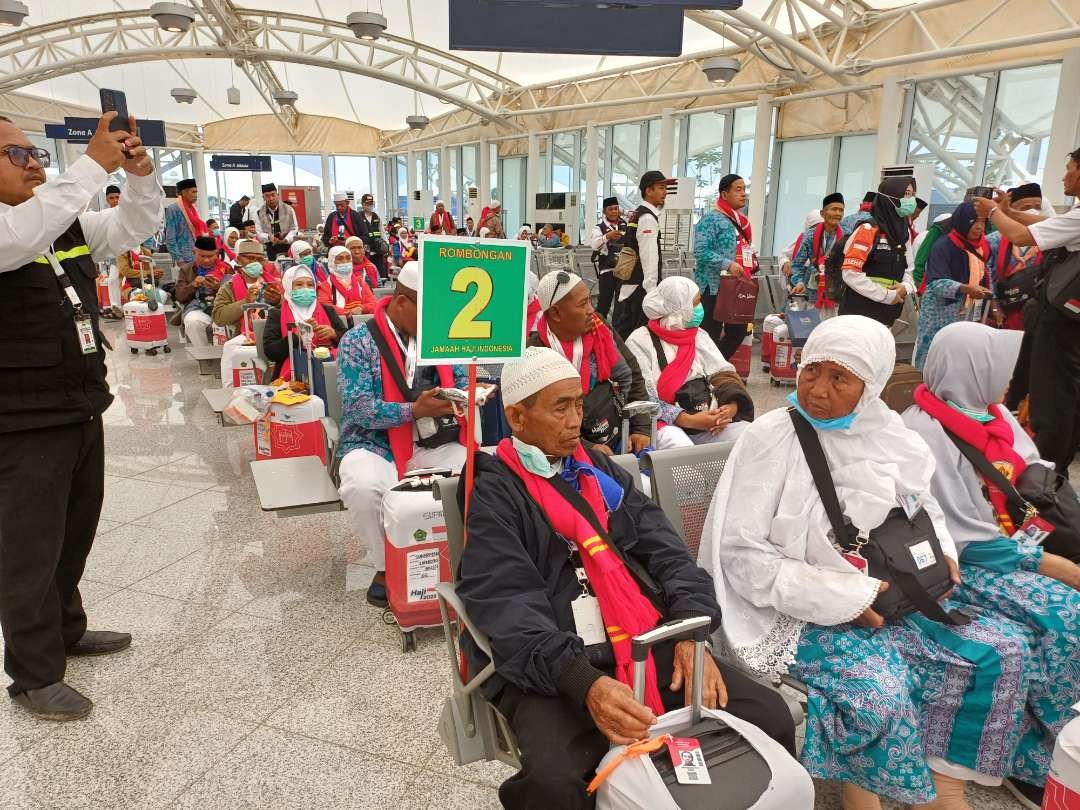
top-left (498, 644), bottom-right (795, 810)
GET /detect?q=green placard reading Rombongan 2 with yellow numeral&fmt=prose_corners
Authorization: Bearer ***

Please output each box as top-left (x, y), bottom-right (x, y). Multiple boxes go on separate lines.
top-left (417, 231), bottom-right (531, 365)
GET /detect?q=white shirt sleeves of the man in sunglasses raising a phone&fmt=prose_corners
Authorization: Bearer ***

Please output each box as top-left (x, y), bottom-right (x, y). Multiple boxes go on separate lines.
top-left (0, 154), bottom-right (165, 272)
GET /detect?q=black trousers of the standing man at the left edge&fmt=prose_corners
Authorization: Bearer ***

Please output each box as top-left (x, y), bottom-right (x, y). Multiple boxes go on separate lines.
top-left (0, 417), bottom-right (105, 694)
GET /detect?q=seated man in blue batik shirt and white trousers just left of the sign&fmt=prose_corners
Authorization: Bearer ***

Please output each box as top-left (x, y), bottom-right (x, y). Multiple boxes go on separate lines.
top-left (338, 261), bottom-right (469, 607)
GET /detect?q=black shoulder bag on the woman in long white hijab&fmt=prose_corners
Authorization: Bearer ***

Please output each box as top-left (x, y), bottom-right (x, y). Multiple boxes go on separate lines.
top-left (788, 408), bottom-right (971, 625)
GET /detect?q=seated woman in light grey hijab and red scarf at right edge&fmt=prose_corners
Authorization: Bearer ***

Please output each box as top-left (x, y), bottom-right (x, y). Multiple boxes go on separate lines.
top-left (904, 321), bottom-right (1080, 806)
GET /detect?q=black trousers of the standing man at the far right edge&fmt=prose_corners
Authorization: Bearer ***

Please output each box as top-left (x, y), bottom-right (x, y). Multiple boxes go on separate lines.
top-left (1029, 306), bottom-right (1080, 477)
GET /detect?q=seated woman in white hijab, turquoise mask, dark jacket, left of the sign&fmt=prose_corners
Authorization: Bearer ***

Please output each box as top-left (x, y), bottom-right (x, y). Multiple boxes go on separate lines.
top-left (262, 265), bottom-right (349, 379)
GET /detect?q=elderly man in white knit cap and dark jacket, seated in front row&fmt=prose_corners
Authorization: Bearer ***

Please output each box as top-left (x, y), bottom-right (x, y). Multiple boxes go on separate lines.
top-left (457, 348), bottom-right (795, 810)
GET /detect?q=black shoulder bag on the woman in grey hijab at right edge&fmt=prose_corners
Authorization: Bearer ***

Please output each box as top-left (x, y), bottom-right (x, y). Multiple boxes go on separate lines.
top-left (945, 430), bottom-right (1080, 563)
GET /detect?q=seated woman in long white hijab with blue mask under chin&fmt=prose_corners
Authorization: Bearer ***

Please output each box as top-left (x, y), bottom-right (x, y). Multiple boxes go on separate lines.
top-left (699, 315), bottom-right (1032, 810)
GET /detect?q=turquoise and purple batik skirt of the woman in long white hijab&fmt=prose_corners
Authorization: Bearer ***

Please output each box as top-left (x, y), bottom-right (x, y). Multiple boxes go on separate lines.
top-left (789, 615), bottom-right (1032, 805)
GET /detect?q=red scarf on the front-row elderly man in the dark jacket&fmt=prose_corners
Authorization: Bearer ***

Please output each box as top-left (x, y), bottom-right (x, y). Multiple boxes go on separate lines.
top-left (496, 438), bottom-right (664, 717)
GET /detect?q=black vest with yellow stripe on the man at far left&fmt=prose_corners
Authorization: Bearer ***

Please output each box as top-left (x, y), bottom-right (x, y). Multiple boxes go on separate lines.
top-left (0, 219), bottom-right (112, 433)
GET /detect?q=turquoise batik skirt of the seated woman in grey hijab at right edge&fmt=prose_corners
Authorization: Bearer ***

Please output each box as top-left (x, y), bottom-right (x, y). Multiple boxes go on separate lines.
top-left (955, 538), bottom-right (1080, 785)
